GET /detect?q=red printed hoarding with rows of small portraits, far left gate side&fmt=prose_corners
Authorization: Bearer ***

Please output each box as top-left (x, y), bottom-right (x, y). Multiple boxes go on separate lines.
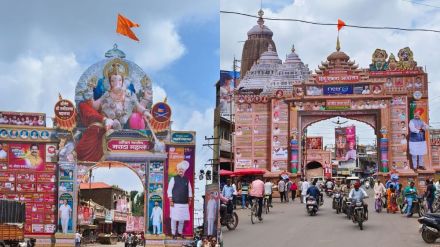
top-left (0, 142), bottom-right (56, 235)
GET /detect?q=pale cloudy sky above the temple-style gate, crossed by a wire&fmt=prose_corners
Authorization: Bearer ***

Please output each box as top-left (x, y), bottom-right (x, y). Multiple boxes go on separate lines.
top-left (220, 0), bottom-right (440, 147)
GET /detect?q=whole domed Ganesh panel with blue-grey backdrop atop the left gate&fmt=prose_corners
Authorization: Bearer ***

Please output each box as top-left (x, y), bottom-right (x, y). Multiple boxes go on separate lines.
top-left (75, 44), bottom-right (171, 162)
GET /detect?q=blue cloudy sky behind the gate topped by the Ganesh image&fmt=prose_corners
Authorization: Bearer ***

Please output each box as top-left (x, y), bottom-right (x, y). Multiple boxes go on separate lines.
top-left (0, 0), bottom-right (219, 193)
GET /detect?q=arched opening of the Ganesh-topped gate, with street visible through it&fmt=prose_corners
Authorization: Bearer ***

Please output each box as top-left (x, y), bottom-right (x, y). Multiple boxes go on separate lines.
top-left (77, 161), bottom-right (147, 239)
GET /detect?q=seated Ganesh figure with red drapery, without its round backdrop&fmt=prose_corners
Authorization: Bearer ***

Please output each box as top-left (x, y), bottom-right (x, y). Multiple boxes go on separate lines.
top-left (76, 62), bottom-right (151, 161)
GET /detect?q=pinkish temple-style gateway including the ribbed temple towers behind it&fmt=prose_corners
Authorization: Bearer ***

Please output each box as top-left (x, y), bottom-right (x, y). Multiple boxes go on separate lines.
top-left (234, 12), bottom-right (434, 185)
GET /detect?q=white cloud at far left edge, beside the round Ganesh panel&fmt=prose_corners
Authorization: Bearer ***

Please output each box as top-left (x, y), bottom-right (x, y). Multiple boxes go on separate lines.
top-left (0, 53), bottom-right (83, 120)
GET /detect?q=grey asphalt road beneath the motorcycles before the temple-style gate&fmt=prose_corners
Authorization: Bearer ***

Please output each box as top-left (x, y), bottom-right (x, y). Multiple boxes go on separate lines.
top-left (222, 190), bottom-right (430, 247)
